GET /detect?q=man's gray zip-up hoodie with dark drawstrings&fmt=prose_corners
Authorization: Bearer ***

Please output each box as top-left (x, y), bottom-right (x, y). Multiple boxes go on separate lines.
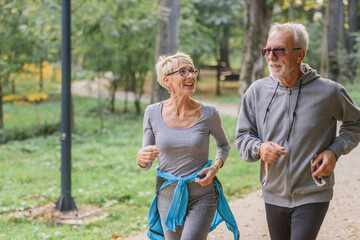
top-left (235, 64), bottom-right (360, 208)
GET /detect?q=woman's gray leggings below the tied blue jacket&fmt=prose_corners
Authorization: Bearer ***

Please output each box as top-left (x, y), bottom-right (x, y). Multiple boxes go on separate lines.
top-left (157, 182), bottom-right (218, 240)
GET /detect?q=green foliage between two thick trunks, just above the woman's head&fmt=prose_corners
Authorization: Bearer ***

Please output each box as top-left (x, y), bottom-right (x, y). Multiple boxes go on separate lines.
top-left (179, 0), bottom-right (243, 66)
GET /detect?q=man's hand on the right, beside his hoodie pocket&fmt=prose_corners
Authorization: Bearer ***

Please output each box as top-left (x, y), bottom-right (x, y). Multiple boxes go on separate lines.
top-left (311, 149), bottom-right (336, 177)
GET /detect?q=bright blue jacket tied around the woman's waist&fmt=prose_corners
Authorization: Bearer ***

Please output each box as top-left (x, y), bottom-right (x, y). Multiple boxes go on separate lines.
top-left (147, 160), bottom-right (240, 240)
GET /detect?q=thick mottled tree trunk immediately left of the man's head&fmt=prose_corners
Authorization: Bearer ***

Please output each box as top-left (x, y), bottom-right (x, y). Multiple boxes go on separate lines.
top-left (239, 0), bottom-right (273, 104)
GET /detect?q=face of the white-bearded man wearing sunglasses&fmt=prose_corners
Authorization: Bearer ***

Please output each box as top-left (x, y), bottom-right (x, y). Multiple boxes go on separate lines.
top-left (265, 30), bottom-right (301, 80)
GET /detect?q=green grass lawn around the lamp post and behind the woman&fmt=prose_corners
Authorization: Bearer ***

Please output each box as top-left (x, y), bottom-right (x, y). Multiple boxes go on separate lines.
top-left (0, 95), bottom-right (260, 239)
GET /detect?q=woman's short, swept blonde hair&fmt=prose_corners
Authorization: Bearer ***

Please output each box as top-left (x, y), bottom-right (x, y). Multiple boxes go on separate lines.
top-left (155, 52), bottom-right (195, 91)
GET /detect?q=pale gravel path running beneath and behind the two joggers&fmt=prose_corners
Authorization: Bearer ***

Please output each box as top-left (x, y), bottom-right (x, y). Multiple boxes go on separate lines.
top-left (72, 82), bottom-right (360, 240)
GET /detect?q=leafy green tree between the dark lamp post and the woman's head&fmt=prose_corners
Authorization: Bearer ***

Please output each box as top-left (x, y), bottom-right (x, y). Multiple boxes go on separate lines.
top-left (74, 0), bottom-right (158, 113)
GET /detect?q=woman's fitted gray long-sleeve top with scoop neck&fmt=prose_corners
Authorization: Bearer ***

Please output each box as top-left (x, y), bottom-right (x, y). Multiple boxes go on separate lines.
top-left (142, 102), bottom-right (230, 177)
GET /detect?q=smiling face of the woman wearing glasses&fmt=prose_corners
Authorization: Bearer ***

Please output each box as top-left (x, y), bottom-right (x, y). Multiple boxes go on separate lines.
top-left (167, 63), bottom-right (197, 95)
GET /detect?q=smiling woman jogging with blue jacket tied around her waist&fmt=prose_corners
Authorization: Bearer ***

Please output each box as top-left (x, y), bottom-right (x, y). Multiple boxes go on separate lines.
top-left (137, 52), bottom-right (239, 240)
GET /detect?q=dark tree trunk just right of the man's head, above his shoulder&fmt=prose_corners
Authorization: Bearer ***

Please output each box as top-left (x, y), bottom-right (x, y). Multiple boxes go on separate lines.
top-left (328, 0), bottom-right (342, 81)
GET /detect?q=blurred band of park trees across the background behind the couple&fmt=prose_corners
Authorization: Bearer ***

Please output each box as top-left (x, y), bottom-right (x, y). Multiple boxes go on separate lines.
top-left (0, 0), bottom-right (360, 128)
